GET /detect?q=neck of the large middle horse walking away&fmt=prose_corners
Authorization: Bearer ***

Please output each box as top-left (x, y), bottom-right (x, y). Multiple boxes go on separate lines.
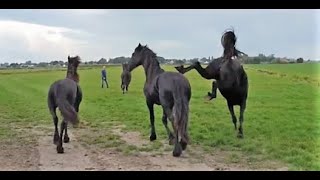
top-left (142, 55), bottom-right (164, 83)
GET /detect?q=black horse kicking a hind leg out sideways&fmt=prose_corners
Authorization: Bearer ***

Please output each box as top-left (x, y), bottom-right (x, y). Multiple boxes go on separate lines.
top-left (175, 31), bottom-right (249, 138)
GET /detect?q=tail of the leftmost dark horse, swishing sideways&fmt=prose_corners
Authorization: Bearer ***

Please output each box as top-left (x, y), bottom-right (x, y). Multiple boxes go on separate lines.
top-left (57, 98), bottom-right (79, 125)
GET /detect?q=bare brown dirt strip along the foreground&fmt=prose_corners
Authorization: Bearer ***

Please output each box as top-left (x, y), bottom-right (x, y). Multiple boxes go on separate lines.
top-left (0, 124), bottom-right (287, 171)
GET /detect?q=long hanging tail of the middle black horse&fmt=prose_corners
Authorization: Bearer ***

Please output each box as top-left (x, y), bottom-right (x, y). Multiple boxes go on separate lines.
top-left (173, 79), bottom-right (190, 143)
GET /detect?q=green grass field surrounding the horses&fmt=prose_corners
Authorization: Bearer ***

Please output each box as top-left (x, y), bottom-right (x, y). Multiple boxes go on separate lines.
top-left (0, 64), bottom-right (320, 170)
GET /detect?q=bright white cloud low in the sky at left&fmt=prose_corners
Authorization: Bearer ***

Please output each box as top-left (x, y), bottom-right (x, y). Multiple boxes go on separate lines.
top-left (0, 20), bottom-right (88, 62)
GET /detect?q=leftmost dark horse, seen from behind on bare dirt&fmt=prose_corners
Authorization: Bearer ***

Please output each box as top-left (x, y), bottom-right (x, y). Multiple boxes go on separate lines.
top-left (48, 56), bottom-right (82, 153)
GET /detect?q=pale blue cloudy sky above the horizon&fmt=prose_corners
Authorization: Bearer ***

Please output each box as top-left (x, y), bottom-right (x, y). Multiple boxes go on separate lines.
top-left (0, 9), bottom-right (320, 63)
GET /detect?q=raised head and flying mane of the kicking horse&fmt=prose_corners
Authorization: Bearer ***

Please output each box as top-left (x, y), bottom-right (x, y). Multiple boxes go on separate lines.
top-left (221, 29), bottom-right (240, 59)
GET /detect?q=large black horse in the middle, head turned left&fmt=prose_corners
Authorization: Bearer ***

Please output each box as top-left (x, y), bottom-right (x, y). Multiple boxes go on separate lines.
top-left (128, 43), bottom-right (191, 157)
